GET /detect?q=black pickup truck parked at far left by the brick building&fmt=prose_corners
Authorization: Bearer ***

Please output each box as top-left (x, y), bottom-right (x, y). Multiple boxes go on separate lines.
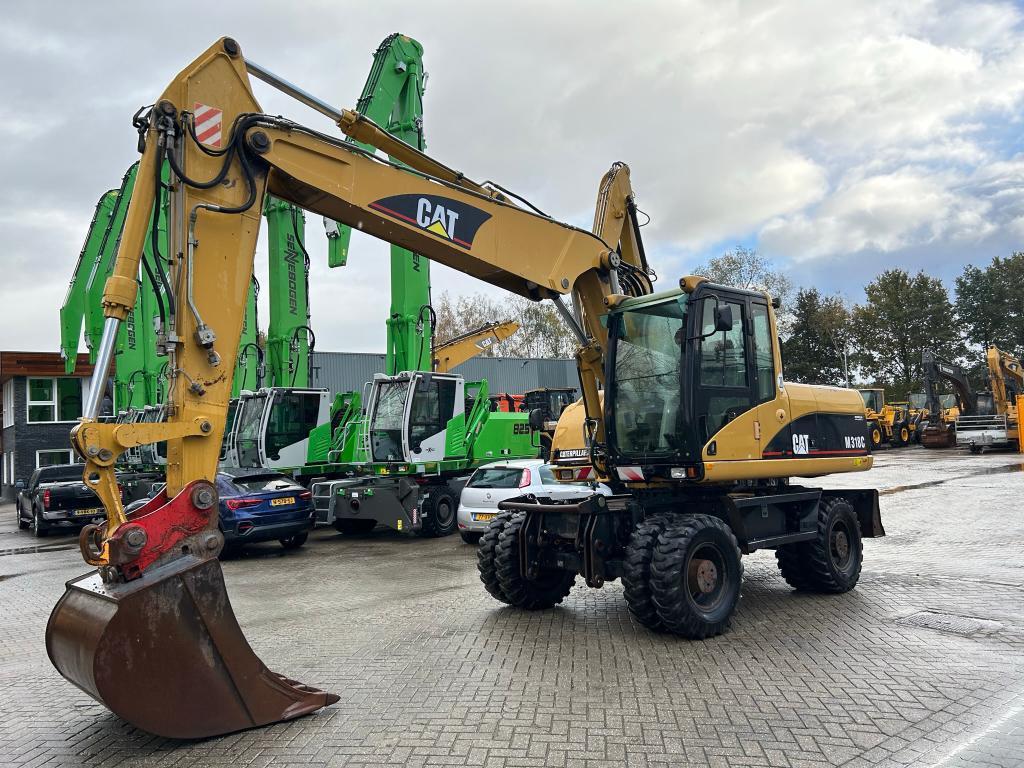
top-left (17, 464), bottom-right (104, 537)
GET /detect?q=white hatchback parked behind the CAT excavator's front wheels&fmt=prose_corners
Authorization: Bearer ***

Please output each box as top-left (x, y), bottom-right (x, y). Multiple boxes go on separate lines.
top-left (459, 459), bottom-right (611, 544)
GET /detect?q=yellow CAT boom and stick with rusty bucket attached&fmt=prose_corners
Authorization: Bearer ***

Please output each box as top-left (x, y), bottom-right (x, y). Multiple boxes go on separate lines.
top-left (47, 38), bottom-right (634, 738)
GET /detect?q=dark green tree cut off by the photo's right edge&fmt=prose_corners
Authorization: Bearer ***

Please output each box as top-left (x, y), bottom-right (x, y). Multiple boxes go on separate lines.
top-left (956, 252), bottom-right (1024, 354)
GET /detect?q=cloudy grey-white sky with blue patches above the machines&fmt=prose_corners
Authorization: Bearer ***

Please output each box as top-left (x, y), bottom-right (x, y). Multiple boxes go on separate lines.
top-left (0, 0), bottom-right (1024, 351)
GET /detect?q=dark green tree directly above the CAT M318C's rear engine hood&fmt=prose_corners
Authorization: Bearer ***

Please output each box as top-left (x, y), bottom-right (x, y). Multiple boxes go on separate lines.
top-left (781, 288), bottom-right (853, 386)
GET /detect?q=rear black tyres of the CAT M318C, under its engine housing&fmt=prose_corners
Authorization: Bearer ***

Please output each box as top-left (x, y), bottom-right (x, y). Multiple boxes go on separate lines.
top-left (775, 498), bottom-right (864, 594)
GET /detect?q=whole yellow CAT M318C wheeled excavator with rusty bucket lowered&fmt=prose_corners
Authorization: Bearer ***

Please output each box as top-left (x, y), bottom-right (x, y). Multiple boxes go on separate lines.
top-left (46, 38), bottom-right (884, 738)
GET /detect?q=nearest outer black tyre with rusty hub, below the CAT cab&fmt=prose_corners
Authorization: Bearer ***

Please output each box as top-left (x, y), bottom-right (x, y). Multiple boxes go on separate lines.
top-left (650, 515), bottom-right (743, 640)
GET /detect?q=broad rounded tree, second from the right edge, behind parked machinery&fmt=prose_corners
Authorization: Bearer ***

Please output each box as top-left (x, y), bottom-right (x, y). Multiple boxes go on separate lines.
top-left (853, 269), bottom-right (959, 399)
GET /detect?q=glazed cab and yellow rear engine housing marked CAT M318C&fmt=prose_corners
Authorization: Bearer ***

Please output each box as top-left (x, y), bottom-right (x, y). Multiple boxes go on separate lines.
top-left (604, 278), bottom-right (867, 480)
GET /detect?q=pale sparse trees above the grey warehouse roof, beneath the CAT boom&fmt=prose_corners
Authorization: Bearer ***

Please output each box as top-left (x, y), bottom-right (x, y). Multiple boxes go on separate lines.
top-left (434, 292), bottom-right (579, 357)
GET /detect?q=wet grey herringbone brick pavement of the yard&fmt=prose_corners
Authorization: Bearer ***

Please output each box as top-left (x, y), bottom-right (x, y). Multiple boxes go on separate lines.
top-left (0, 450), bottom-right (1024, 768)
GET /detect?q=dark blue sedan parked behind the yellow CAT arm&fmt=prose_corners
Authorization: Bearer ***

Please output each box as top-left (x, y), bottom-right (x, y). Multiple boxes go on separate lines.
top-left (217, 469), bottom-right (315, 550)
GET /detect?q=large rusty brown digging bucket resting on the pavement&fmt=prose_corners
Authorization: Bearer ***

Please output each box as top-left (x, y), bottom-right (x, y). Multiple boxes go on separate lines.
top-left (46, 555), bottom-right (338, 738)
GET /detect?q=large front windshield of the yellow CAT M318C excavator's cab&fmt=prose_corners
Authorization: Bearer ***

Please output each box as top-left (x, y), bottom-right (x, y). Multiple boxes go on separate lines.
top-left (613, 300), bottom-right (686, 455)
